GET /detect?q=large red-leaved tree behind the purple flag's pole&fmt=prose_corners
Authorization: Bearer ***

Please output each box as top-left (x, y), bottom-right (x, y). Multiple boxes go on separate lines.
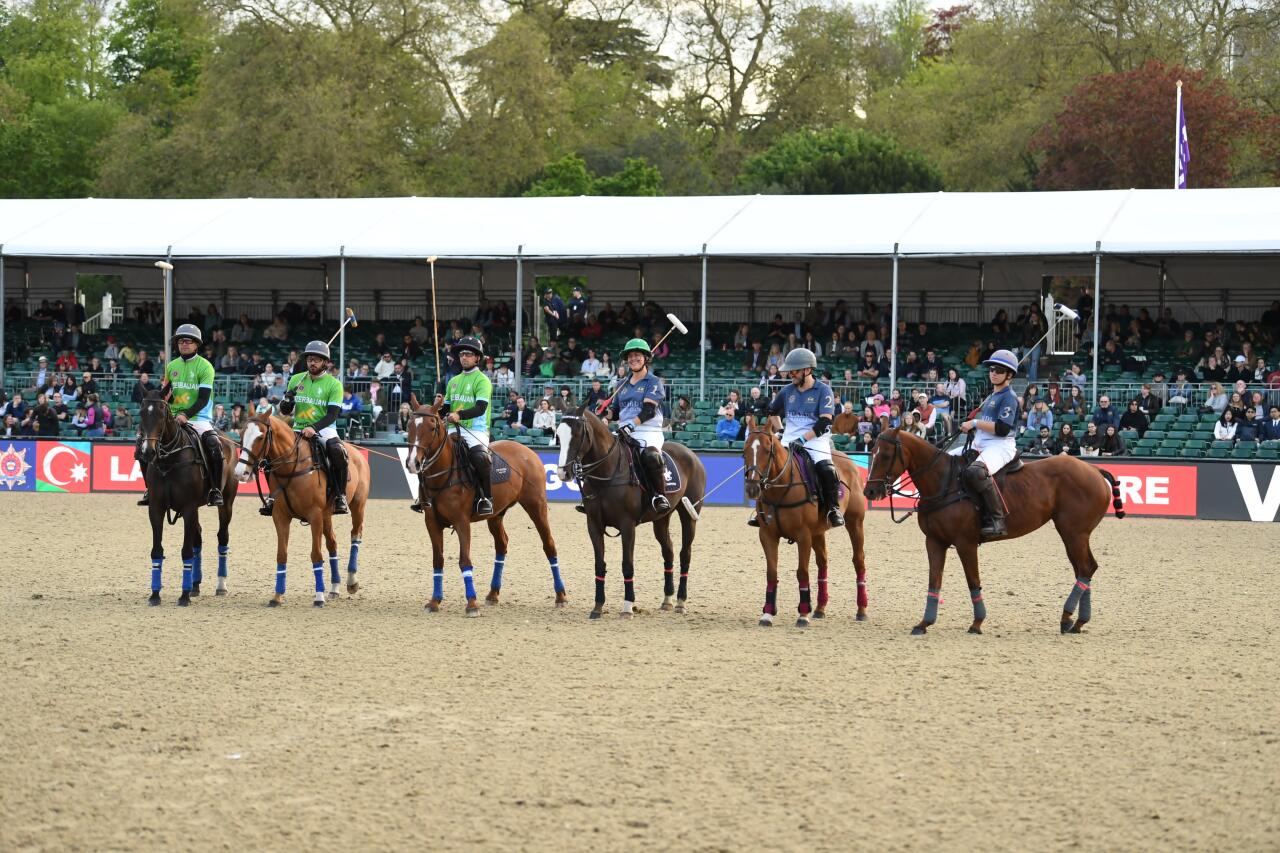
top-left (1032, 60), bottom-right (1261, 190)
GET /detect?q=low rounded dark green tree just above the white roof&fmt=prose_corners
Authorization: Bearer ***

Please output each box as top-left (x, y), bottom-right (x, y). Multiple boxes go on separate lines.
top-left (739, 128), bottom-right (942, 195)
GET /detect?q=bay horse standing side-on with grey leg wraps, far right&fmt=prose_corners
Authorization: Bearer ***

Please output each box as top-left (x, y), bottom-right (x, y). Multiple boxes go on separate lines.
top-left (863, 429), bottom-right (1124, 634)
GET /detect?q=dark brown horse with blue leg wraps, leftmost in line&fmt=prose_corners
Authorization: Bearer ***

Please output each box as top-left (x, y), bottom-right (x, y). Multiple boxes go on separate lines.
top-left (138, 392), bottom-right (236, 607)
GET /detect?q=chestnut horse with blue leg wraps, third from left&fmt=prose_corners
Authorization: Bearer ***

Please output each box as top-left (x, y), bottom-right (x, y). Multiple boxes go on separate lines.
top-left (404, 405), bottom-right (568, 616)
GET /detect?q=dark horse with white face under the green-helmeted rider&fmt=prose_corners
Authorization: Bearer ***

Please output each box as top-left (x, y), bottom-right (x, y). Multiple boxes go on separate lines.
top-left (557, 406), bottom-right (707, 619)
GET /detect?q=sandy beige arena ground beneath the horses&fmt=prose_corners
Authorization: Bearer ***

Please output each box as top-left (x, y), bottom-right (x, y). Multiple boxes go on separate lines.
top-left (0, 494), bottom-right (1280, 850)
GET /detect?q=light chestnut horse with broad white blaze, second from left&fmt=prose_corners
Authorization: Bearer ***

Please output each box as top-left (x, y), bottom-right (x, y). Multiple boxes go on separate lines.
top-left (236, 415), bottom-right (370, 607)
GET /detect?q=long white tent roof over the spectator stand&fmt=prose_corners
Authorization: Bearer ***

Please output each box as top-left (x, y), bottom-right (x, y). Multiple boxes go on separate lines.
top-left (0, 188), bottom-right (1280, 259)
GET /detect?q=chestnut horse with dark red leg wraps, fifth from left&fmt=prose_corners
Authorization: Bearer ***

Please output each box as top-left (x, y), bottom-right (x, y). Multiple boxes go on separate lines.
top-left (742, 416), bottom-right (867, 628)
